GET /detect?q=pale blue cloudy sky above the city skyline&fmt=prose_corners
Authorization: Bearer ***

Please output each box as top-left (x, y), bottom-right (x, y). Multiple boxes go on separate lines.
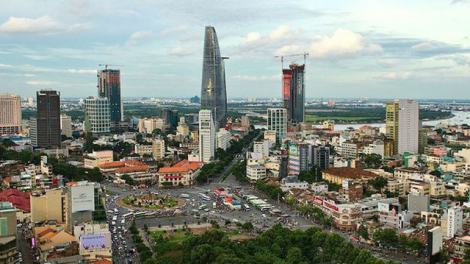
top-left (0, 0), bottom-right (470, 99)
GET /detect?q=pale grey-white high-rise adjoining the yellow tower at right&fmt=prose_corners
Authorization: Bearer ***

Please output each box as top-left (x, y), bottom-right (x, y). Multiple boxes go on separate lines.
top-left (398, 100), bottom-right (419, 155)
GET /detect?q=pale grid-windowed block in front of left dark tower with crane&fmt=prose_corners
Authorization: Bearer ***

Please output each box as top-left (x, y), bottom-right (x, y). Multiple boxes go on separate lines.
top-left (85, 97), bottom-right (111, 134)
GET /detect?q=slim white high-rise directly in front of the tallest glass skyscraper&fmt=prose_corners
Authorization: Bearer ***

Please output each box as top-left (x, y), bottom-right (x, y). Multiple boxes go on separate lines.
top-left (199, 109), bottom-right (215, 162)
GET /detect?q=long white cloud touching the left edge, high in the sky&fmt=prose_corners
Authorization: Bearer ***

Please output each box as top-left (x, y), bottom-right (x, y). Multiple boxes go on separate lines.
top-left (0, 16), bottom-right (87, 34)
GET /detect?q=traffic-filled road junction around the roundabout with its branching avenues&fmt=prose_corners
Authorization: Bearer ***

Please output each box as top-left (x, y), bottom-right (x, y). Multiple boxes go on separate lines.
top-left (103, 135), bottom-right (423, 264)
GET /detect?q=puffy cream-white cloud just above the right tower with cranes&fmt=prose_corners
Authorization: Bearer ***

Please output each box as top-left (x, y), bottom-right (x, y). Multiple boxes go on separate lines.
top-left (310, 28), bottom-right (383, 58)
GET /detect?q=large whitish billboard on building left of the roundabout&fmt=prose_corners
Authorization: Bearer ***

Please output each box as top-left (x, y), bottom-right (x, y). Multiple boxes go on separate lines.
top-left (70, 185), bottom-right (95, 213)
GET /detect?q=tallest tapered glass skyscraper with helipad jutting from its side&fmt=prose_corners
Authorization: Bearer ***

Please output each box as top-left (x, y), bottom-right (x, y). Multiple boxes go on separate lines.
top-left (201, 27), bottom-right (227, 127)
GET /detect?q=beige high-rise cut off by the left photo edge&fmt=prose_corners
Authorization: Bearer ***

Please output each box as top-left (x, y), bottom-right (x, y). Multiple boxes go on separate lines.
top-left (0, 94), bottom-right (21, 135)
